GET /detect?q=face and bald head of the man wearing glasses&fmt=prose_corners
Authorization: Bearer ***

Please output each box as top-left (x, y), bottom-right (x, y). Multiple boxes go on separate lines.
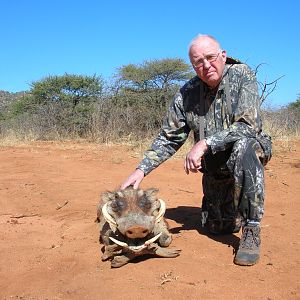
top-left (189, 37), bottom-right (226, 88)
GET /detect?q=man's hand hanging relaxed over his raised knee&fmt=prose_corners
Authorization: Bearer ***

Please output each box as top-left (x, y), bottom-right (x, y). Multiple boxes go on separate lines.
top-left (184, 140), bottom-right (208, 174)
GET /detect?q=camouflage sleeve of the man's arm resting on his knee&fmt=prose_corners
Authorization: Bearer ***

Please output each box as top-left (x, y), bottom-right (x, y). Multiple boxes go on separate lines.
top-left (206, 64), bottom-right (262, 153)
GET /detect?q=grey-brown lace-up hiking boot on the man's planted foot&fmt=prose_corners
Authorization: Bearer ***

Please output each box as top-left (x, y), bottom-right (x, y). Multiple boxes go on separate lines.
top-left (234, 224), bottom-right (260, 266)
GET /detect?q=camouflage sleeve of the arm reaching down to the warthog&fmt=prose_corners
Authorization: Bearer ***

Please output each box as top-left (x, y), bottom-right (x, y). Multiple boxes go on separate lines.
top-left (137, 92), bottom-right (190, 175)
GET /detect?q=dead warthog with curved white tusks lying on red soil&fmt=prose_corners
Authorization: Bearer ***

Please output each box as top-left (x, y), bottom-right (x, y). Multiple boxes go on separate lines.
top-left (96, 187), bottom-right (180, 268)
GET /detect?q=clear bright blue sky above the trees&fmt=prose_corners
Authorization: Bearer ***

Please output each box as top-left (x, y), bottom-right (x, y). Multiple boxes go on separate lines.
top-left (0, 0), bottom-right (300, 106)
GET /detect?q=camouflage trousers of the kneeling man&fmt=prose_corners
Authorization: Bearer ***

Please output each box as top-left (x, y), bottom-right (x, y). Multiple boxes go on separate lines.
top-left (202, 138), bottom-right (271, 233)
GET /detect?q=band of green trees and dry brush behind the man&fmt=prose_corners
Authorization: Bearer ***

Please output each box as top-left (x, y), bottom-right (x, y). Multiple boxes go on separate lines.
top-left (0, 59), bottom-right (300, 145)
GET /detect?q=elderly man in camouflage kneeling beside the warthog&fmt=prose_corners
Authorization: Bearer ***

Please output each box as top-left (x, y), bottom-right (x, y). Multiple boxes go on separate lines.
top-left (121, 35), bottom-right (272, 265)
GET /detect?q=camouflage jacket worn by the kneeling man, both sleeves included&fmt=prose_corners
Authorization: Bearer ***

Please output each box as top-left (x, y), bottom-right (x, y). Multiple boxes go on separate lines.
top-left (137, 64), bottom-right (271, 175)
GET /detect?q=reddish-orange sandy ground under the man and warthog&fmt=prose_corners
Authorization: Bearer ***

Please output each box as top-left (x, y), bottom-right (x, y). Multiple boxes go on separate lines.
top-left (0, 142), bottom-right (300, 300)
